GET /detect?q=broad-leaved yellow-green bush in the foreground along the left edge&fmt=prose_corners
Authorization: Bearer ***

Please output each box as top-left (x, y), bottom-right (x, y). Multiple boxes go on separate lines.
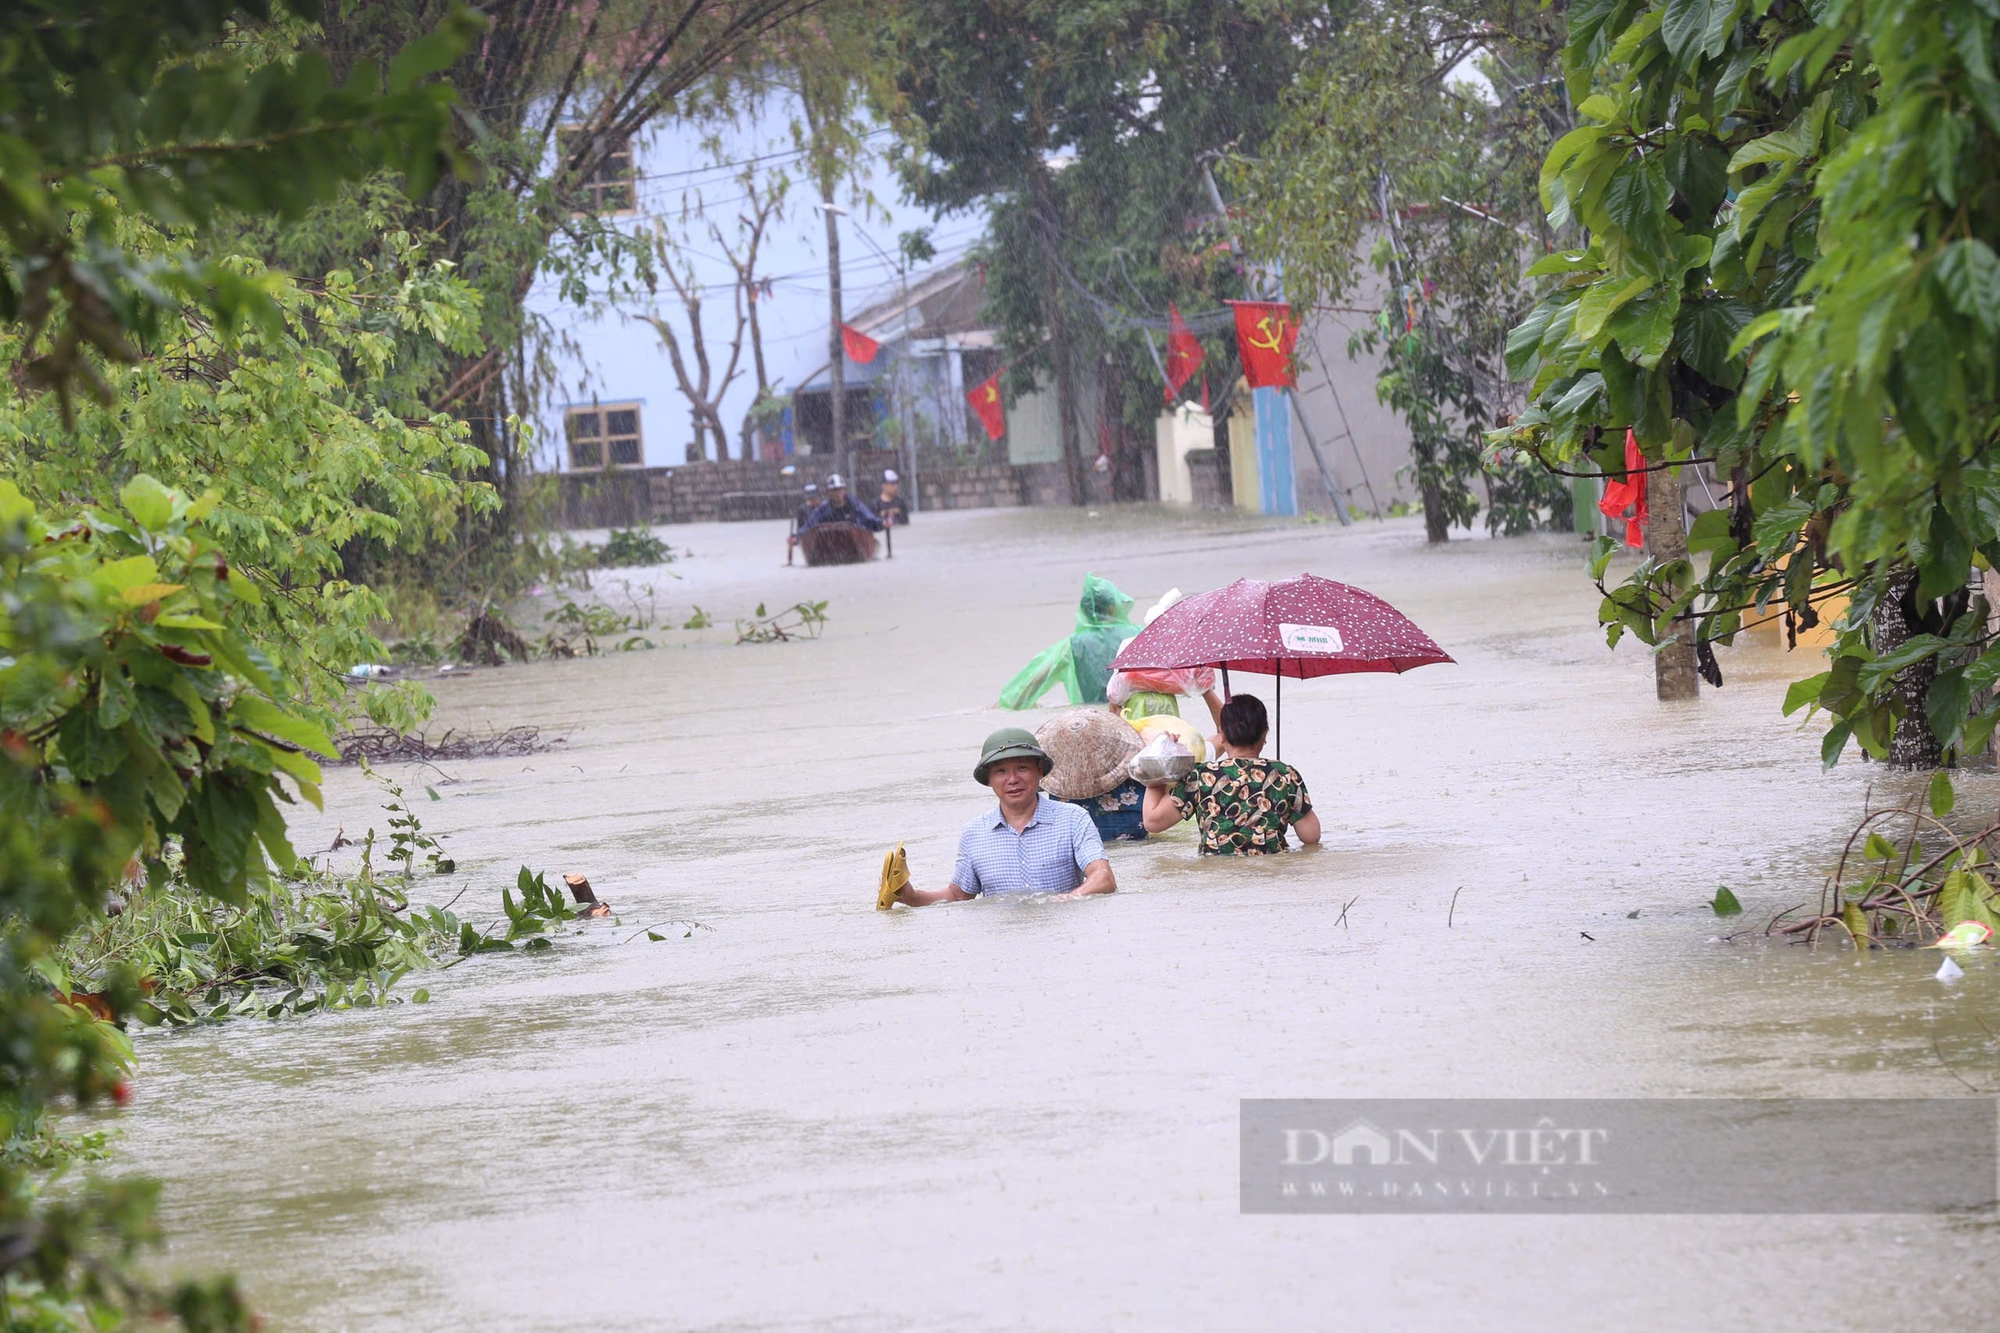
top-left (0, 474), bottom-right (332, 1327)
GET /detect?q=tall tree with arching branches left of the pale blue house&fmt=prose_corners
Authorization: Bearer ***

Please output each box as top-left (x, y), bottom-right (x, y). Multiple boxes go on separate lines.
top-left (256, 0), bottom-right (822, 616)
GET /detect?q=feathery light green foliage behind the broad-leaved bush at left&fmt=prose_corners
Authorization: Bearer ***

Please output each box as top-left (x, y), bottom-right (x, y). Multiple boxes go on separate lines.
top-left (0, 226), bottom-right (494, 721)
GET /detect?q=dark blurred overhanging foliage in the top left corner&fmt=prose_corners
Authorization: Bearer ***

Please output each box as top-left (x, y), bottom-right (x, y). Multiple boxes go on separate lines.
top-left (0, 0), bottom-right (478, 416)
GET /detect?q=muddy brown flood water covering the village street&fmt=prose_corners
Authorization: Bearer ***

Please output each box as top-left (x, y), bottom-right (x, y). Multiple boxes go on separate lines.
top-left (120, 508), bottom-right (2000, 1333)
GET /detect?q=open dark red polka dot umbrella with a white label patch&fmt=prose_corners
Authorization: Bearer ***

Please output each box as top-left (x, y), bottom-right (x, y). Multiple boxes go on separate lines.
top-left (1112, 574), bottom-right (1452, 752)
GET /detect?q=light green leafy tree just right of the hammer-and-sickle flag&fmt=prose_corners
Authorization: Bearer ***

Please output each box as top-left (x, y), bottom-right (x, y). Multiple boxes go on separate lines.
top-left (1230, 0), bottom-right (1570, 540)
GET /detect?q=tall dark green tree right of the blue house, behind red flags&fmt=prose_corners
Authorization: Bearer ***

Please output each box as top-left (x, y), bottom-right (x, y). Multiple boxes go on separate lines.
top-left (898, 0), bottom-right (1332, 502)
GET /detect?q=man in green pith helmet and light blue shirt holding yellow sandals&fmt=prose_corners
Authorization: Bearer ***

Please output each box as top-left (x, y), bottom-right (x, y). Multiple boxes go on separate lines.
top-left (876, 727), bottom-right (1118, 907)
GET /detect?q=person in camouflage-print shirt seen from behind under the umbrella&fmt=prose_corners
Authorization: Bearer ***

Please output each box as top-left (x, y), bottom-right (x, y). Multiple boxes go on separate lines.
top-left (1142, 695), bottom-right (1320, 857)
